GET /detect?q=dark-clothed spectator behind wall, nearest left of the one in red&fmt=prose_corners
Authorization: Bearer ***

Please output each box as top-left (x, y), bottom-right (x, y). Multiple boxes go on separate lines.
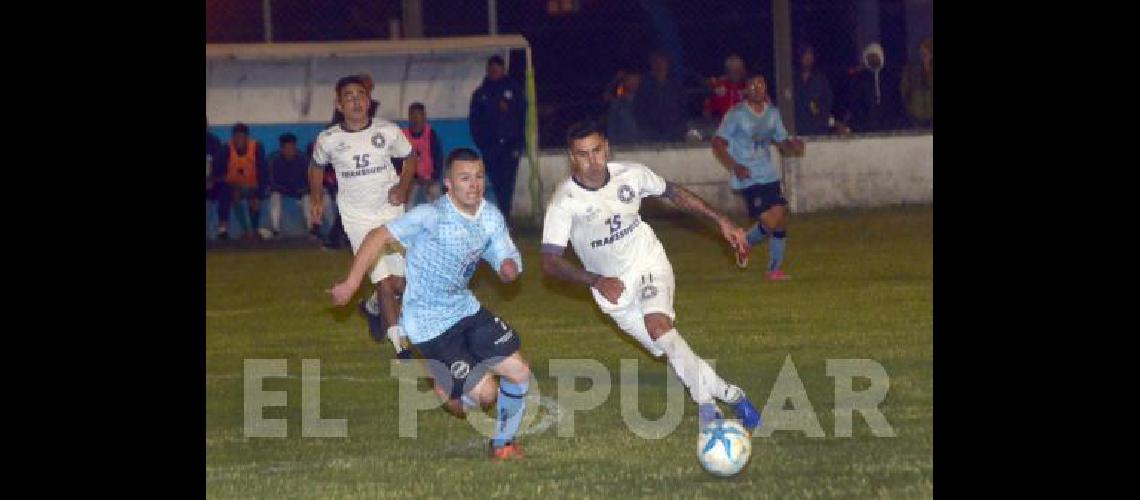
top-left (634, 51), bottom-right (685, 142)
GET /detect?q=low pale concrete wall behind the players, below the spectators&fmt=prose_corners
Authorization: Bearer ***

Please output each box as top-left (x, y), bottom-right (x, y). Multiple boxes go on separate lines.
top-left (512, 133), bottom-right (934, 218)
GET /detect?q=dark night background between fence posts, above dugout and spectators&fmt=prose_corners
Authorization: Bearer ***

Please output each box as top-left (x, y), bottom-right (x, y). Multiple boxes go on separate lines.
top-left (206, 0), bottom-right (933, 142)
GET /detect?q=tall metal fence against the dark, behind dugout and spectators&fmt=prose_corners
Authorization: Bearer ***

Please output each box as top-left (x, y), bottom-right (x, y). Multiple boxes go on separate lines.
top-left (205, 0), bottom-right (934, 147)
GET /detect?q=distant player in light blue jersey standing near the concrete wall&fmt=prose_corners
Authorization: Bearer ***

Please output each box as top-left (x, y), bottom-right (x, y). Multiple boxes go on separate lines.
top-left (713, 76), bottom-right (804, 281)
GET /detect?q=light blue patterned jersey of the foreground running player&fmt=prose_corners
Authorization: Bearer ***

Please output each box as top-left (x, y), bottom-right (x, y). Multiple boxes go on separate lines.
top-left (386, 196), bottom-right (522, 344)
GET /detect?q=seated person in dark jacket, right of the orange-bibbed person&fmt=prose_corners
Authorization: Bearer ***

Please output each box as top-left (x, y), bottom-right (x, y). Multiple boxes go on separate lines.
top-left (259, 132), bottom-right (312, 239)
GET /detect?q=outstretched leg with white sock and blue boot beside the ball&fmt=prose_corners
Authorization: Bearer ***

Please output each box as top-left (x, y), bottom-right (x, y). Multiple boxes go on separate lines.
top-left (645, 313), bottom-right (760, 431)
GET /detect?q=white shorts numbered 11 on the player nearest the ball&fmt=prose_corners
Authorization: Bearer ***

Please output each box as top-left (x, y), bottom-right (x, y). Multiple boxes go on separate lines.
top-left (589, 259), bottom-right (677, 358)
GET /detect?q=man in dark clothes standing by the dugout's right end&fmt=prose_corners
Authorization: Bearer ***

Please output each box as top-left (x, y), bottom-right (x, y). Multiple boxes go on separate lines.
top-left (469, 56), bottom-right (527, 224)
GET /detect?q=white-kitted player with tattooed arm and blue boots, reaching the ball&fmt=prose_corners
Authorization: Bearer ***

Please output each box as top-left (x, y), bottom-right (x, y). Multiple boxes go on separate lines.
top-left (543, 121), bottom-right (760, 431)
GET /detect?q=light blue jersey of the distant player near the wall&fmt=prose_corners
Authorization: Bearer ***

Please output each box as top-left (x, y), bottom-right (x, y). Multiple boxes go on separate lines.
top-left (716, 101), bottom-right (788, 189)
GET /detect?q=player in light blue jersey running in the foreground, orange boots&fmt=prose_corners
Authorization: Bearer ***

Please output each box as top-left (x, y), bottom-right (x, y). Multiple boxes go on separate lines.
top-left (328, 148), bottom-right (530, 459)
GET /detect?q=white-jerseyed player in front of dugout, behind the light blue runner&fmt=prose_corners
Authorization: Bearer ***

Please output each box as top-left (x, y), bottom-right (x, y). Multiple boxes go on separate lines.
top-left (309, 75), bottom-right (418, 358)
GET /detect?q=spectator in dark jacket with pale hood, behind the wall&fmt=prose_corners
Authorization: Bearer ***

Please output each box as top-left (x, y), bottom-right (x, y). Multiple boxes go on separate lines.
top-left (845, 43), bottom-right (904, 132)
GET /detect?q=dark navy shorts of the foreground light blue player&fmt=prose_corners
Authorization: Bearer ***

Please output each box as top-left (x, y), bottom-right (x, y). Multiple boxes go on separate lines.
top-left (415, 308), bottom-right (522, 400)
